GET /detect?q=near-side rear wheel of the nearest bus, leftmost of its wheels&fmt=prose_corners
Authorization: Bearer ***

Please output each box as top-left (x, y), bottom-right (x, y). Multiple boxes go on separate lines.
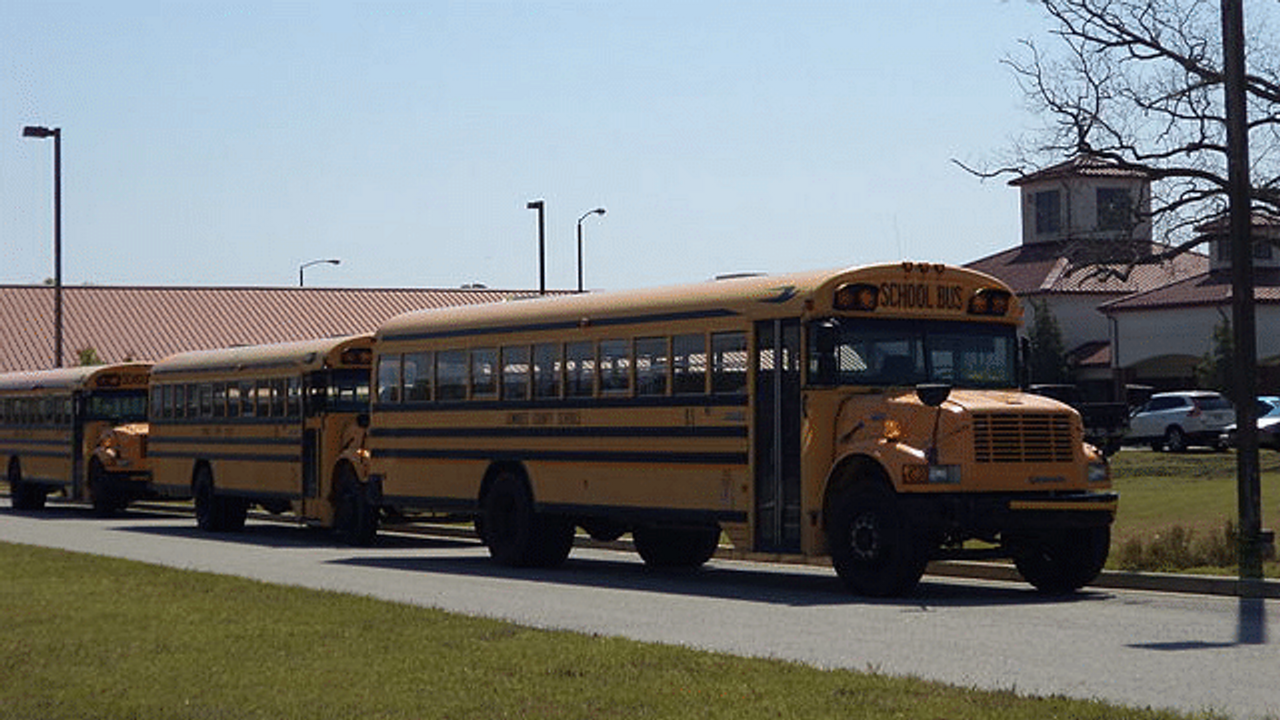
top-left (480, 469), bottom-right (573, 568)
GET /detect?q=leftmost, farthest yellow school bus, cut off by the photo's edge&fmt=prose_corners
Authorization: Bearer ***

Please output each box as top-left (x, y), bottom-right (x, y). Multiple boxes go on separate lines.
top-left (0, 363), bottom-right (151, 514)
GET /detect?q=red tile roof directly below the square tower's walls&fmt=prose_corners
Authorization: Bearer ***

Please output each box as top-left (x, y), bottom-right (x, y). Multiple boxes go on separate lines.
top-left (965, 241), bottom-right (1210, 295)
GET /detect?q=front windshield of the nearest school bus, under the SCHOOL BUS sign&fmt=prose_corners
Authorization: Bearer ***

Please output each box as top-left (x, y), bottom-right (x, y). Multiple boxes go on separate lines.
top-left (809, 318), bottom-right (1018, 388)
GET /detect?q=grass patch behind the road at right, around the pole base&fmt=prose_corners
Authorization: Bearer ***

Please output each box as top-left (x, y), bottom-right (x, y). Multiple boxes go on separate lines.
top-left (1108, 450), bottom-right (1280, 578)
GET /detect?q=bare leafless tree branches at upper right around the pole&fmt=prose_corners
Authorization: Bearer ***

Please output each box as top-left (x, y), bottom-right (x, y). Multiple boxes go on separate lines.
top-left (955, 0), bottom-right (1280, 278)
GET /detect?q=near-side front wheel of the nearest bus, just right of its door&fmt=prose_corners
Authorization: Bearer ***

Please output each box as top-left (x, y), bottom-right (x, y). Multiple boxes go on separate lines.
top-left (827, 482), bottom-right (928, 597)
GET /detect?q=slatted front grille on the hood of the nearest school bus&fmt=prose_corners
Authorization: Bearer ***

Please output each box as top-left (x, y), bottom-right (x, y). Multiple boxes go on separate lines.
top-left (973, 413), bottom-right (1075, 462)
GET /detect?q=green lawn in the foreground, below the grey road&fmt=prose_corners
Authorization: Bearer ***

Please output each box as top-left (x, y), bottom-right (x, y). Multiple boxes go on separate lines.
top-left (0, 543), bottom-right (1218, 720)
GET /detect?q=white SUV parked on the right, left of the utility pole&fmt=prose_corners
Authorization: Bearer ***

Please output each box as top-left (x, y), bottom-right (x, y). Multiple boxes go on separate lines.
top-left (1125, 389), bottom-right (1235, 452)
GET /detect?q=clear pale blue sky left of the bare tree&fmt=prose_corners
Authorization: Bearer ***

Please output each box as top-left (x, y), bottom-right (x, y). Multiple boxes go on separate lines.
top-left (0, 0), bottom-right (1047, 290)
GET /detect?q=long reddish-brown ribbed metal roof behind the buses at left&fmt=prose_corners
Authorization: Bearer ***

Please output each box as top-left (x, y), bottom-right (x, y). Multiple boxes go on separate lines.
top-left (0, 286), bottom-right (550, 372)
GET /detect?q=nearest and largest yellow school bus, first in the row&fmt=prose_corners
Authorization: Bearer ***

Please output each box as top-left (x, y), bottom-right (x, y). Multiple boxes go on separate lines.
top-left (367, 263), bottom-right (1116, 596)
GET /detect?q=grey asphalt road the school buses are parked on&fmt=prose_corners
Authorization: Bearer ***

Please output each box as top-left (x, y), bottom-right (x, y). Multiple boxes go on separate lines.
top-left (0, 500), bottom-right (1280, 719)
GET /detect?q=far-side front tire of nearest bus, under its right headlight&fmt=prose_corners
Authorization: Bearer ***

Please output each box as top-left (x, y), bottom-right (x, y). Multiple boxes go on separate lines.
top-left (1014, 525), bottom-right (1111, 594)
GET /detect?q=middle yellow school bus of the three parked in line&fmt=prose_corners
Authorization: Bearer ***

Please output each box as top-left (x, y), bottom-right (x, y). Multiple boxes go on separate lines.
top-left (150, 336), bottom-right (374, 542)
